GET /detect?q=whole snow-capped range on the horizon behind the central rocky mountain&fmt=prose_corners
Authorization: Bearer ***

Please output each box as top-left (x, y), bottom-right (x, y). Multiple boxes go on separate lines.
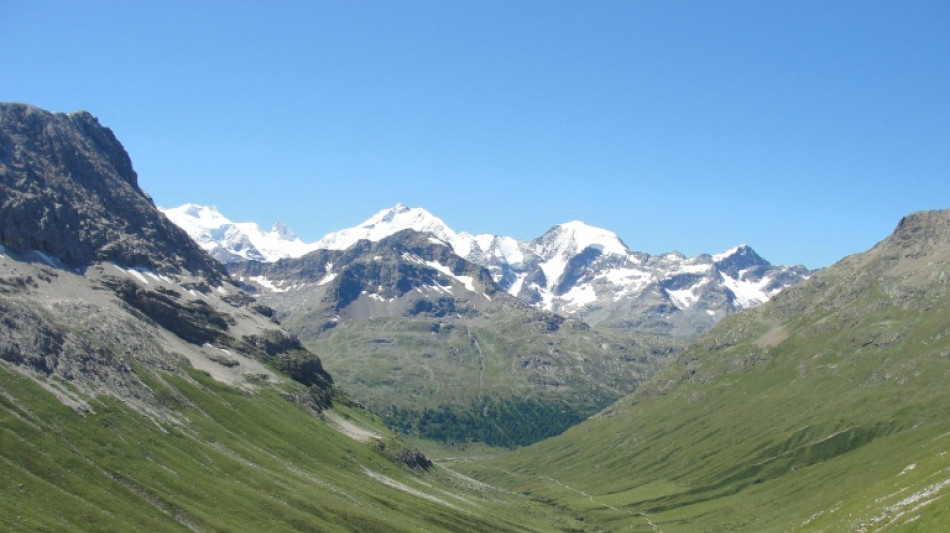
top-left (166, 204), bottom-right (809, 336)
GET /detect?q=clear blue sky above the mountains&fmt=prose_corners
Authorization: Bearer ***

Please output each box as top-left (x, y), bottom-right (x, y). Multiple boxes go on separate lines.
top-left (0, 0), bottom-right (950, 268)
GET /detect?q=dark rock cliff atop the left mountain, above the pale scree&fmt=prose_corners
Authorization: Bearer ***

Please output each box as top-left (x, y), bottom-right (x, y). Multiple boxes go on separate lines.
top-left (0, 104), bottom-right (226, 281)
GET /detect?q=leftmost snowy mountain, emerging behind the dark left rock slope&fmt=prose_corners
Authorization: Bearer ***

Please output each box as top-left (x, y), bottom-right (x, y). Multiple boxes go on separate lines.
top-left (161, 204), bottom-right (318, 263)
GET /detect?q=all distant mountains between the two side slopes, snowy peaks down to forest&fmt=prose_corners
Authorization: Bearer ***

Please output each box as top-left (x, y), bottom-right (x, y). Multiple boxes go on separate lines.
top-left (165, 204), bottom-right (808, 446)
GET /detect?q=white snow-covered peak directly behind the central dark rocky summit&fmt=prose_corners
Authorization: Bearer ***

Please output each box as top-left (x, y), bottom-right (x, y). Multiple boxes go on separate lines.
top-left (314, 204), bottom-right (458, 250)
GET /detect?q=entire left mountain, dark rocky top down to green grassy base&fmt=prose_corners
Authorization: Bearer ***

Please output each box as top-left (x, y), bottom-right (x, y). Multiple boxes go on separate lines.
top-left (0, 104), bottom-right (596, 533)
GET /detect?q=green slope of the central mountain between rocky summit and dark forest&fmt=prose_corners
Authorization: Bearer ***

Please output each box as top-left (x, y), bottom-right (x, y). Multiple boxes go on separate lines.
top-left (305, 312), bottom-right (672, 445)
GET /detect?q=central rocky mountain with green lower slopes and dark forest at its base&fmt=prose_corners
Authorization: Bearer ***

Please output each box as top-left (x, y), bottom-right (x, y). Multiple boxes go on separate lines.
top-left (231, 229), bottom-right (677, 445)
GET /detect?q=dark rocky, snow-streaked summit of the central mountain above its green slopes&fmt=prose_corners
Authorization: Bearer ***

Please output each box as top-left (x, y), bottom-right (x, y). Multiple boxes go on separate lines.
top-left (229, 230), bottom-right (502, 327)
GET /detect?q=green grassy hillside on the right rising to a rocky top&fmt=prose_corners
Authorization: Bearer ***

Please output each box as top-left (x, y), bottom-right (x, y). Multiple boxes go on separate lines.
top-left (459, 211), bottom-right (950, 533)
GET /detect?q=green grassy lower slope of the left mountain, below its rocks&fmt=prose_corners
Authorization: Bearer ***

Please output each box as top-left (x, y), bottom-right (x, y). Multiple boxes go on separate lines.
top-left (0, 364), bottom-right (592, 532)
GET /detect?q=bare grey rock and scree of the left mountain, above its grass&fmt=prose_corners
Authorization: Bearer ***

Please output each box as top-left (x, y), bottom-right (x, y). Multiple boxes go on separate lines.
top-left (0, 104), bottom-right (332, 412)
